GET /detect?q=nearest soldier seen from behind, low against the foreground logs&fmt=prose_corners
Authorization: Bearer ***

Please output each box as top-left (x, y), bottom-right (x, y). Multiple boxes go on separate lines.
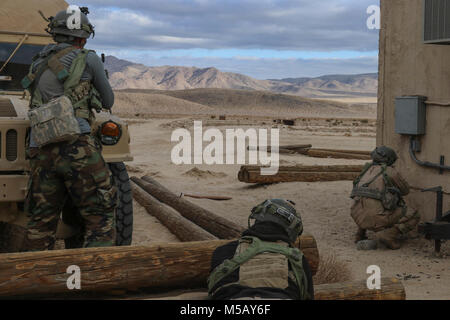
top-left (208, 199), bottom-right (314, 300)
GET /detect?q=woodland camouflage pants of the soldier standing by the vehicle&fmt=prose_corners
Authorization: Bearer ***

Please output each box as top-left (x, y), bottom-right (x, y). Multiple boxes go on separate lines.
top-left (24, 135), bottom-right (117, 251)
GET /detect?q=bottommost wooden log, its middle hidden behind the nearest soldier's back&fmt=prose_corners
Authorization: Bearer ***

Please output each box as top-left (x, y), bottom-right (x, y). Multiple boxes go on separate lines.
top-left (136, 278), bottom-right (406, 300)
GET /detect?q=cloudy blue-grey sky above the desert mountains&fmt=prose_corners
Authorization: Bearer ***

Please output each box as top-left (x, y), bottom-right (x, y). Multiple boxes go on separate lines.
top-left (64, 0), bottom-right (379, 79)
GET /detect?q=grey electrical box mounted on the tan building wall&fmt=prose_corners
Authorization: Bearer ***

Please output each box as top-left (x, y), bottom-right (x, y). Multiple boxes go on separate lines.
top-left (395, 96), bottom-right (427, 135)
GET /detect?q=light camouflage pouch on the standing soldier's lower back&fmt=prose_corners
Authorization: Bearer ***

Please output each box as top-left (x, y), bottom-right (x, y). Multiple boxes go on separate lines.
top-left (28, 96), bottom-right (81, 148)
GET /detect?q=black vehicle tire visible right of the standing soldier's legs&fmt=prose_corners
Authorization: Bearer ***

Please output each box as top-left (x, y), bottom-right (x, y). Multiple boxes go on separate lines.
top-left (109, 162), bottom-right (133, 246)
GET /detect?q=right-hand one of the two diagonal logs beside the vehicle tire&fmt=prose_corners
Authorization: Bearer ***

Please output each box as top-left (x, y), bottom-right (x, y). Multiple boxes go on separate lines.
top-left (131, 177), bottom-right (244, 239)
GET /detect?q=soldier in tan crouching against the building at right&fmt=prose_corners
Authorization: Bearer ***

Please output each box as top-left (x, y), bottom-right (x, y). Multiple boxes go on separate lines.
top-left (351, 146), bottom-right (420, 249)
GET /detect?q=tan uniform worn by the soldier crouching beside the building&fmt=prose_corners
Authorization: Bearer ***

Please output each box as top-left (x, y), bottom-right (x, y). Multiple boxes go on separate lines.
top-left (351, 164), bottom-right (420, 247)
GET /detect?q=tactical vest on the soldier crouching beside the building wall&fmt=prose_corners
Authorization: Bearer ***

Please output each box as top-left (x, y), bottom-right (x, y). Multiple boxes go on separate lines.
top-left (350, 162), bottom-right (405, 211)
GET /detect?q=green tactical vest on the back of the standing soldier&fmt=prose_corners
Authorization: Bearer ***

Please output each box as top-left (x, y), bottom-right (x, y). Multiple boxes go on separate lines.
top-left (22, 46), bottom-right (102, 123)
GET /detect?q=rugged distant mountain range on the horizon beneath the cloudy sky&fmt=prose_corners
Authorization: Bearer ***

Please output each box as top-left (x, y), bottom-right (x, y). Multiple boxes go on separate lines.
top-left (105, 56), bottom-right (378, 99)
